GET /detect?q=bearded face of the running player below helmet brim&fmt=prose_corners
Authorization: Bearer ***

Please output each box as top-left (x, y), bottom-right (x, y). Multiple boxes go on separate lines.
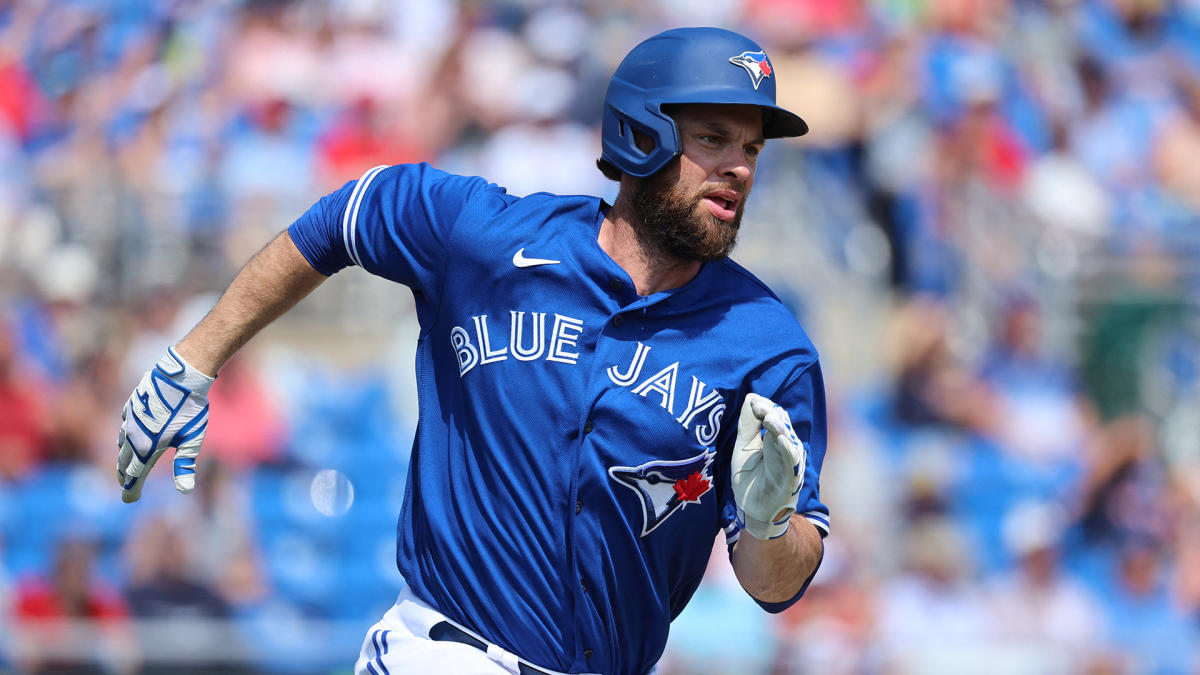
top-left (634, 104), bottom-right (763, 261)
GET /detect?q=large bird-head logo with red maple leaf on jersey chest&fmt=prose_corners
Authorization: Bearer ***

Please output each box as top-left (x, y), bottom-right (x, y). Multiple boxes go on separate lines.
top-left (608, 450), bottom-right (716, 537)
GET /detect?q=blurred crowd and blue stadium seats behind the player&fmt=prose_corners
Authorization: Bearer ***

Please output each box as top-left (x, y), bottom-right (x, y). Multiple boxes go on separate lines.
top-left (0, 0), bottom-right (1200, 675)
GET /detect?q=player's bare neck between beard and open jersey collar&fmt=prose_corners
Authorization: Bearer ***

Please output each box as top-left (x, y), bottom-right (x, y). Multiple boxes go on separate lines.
top-left (596, 204), bottom-right (701, 295)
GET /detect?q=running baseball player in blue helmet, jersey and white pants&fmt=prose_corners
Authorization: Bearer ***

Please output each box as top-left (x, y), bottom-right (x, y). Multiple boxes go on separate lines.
top-left (118, 28), bottom-right (829, 675)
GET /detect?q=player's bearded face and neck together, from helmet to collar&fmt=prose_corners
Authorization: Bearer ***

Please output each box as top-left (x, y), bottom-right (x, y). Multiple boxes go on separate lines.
top-left (599, 104), bottom-right (764, 294)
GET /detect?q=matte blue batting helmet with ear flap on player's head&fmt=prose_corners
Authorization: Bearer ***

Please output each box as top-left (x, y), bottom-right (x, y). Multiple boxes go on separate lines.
top-left (600, 28), bottom-right (809, 177)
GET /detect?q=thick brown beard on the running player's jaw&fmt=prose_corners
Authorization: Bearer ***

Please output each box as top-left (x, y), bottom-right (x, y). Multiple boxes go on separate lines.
top-left (630, 159), bottom-right (745, 262)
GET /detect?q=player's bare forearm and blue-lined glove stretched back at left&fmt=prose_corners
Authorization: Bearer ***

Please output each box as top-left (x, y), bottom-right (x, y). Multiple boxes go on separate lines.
top-left (116, 232), bottom-right (325, 502)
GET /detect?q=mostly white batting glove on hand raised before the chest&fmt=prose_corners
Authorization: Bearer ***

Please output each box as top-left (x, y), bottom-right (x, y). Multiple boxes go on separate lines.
top-left (730, 394), bottom-right (805, 539)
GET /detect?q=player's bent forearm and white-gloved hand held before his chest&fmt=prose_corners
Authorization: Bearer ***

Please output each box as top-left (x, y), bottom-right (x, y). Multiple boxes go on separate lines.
top-left (730, 394), bottom-right (823, 604)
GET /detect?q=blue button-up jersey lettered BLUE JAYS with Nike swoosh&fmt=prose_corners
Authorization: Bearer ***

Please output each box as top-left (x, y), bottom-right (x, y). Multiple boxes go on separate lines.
top-left (289, 165), bottom-right (829, 673)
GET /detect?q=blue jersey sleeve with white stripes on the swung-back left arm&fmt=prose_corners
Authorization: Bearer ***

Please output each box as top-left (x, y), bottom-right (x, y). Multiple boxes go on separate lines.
top-left (288, 163), bottom-right (500, 295)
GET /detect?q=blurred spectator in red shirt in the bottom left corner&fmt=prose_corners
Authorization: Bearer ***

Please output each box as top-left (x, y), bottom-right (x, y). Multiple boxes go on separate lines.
top-left (13, 536), bottom-right (137, 673)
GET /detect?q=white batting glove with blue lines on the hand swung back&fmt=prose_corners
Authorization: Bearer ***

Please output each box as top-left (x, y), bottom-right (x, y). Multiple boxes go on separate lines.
top-left (116, 347), bottom-right (214, 502)
